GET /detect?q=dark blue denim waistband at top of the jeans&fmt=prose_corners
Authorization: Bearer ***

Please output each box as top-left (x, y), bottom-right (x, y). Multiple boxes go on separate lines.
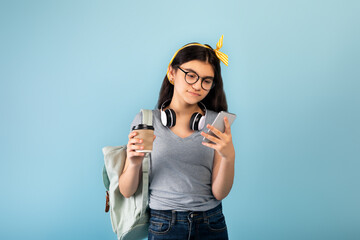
top-left (150, 203), bottom-right (222, 220)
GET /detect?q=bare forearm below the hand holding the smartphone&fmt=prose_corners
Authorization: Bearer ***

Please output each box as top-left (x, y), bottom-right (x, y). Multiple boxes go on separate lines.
top-left (212, 157), bottom-right (235, 200)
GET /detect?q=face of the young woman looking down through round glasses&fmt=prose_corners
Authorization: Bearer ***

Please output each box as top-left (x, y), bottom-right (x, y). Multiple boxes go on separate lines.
top-left (169, 60), bottom-right (214, 104)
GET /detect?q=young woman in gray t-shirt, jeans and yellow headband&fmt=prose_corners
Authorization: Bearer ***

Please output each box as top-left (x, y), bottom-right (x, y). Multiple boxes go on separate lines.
top-left (119, 36), bottom-right (235, 240)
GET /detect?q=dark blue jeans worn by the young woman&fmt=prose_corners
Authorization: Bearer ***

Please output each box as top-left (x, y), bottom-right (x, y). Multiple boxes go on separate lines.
top-left (148, 203), bottom-right (228, 240)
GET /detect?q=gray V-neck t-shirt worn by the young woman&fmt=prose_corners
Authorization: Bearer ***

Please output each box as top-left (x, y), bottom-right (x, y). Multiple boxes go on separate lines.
top-left (130, 109), bottom-right (220, 211)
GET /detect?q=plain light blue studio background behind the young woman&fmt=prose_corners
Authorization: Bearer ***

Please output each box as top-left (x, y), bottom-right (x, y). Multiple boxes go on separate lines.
top-left (0, 0), bottom-right (360, 240)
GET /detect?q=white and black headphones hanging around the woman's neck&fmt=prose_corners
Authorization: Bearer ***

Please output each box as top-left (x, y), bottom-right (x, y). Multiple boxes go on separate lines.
top-left (160, 99), bottom-right (207, 131)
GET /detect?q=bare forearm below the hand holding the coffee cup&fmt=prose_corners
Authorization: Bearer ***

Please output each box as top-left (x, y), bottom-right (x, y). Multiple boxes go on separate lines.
top-left (119, 159), bottom-right (141, 198)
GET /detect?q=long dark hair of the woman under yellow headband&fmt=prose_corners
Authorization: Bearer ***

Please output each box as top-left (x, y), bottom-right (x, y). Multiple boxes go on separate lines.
top-left (157, 43), bottom-right (228, 112)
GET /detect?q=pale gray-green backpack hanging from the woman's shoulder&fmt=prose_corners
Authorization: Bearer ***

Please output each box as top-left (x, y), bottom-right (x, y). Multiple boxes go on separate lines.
top-left (102, 109), bottom-right (153, 240)
